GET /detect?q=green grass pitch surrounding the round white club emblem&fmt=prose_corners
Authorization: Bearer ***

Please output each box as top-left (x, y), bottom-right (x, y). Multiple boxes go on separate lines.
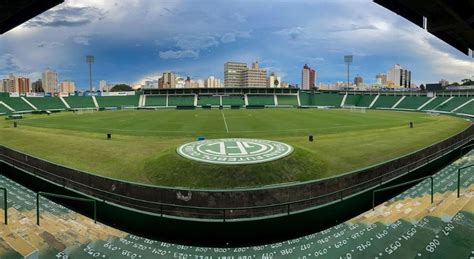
top-left (0, 109), bottom-right (470, 188)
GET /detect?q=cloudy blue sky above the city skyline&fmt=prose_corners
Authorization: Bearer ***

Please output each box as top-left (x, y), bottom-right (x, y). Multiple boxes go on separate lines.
top-left (0, 0), bottom-right (474, 88)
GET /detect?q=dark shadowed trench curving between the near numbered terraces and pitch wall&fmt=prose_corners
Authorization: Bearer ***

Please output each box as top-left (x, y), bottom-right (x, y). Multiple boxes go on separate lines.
top-left (0, 131), bottom-right (471, 247)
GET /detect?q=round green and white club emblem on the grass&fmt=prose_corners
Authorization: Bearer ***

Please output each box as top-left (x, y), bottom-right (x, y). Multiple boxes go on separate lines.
top-left (176, 138), bottom-right (293, 165)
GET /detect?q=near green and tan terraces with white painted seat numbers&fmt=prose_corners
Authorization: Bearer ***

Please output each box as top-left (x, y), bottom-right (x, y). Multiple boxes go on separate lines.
top-left (0, 151), bottom-right (474, 258)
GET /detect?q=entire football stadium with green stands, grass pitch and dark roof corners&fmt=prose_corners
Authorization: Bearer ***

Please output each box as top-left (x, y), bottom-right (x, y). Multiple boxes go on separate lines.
top-left (0, 1), bottom-right (474, 259)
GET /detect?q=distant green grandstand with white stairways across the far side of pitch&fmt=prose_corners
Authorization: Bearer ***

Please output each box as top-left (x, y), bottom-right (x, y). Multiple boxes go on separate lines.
top-left (0, 89), bottom-right (474, 116)
